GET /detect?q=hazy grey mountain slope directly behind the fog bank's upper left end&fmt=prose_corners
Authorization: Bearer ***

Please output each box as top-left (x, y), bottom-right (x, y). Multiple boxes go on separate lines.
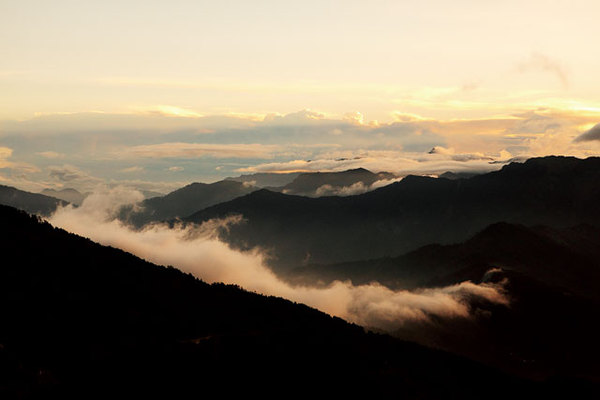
top-left (120, 181), bottom-right (256, 227)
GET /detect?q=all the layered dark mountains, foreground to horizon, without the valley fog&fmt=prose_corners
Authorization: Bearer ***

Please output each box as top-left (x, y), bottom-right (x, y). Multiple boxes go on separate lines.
top-left (0, 157), bottom-right (600, 398)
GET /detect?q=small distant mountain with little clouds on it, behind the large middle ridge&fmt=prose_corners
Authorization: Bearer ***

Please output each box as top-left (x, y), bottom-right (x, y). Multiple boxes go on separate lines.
top-left (272, 168), bottom-right (397, 197)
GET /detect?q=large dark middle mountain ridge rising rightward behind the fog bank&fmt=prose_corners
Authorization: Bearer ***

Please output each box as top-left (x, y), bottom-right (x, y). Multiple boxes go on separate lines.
top-left (185, 157), bottom-right (600, 270)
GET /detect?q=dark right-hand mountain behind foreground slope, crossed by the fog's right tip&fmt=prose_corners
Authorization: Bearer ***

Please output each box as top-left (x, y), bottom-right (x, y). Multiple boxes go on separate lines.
top-left (290, 223), bottom-right (600, 381)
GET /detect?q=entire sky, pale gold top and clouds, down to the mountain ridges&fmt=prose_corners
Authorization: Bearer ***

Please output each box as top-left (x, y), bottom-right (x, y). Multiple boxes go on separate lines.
top-left (0, 0), bottom-right (600, 193)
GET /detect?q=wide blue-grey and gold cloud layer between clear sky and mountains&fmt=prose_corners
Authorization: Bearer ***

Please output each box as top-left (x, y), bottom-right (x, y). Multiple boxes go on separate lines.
top-left (0, 108), bottom-right (600, 193)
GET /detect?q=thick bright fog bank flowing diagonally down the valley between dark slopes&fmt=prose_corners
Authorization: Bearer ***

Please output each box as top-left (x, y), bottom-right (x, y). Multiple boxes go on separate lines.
top-left (49, 188), bottom-right (509, 331)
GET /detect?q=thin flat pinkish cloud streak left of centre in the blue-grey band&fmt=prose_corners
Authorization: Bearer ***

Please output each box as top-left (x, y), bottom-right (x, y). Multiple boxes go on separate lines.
top-left (119, 142), bottom-right (280, 159)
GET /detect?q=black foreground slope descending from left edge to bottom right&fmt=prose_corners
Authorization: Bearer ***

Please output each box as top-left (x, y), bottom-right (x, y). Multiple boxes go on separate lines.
top-left (0, 207), bottom-right (556, 399)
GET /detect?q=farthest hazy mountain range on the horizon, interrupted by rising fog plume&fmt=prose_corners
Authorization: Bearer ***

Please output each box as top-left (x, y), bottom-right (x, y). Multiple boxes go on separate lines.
top-left (0, 168), bottom-right (395, 227)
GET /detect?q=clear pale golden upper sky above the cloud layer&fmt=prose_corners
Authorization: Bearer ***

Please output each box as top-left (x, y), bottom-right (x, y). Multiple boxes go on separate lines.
top-left (0, 0), bottom-right (600, 121)
